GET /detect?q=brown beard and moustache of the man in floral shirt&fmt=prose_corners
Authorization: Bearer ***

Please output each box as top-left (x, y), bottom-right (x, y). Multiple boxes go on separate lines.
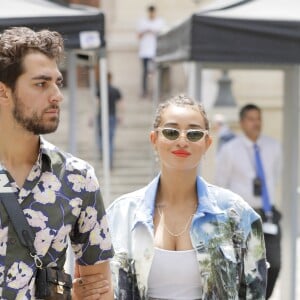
top-left (13, 93), bottom-right (59, 135)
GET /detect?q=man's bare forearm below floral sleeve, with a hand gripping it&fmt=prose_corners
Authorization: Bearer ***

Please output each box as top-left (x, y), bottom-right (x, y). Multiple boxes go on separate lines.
top-left (72, 261), bottom-right (114, 300)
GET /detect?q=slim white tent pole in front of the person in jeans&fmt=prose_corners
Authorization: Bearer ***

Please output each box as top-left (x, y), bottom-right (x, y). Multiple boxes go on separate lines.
top-left (99, 49), bottom-right (111, 206)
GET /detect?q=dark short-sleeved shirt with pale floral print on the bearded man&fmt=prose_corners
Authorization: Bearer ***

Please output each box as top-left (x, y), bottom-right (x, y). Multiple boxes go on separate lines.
top-left (0, 137), bottom-right (113, 300)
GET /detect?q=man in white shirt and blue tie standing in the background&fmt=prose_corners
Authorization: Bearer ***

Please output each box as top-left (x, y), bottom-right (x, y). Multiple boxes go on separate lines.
top-left (215, 104), bottom-right (282, 299)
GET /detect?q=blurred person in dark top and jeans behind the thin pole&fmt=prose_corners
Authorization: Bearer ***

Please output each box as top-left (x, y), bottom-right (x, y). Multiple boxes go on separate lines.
top-left (97, 72), bottom-right (123, 169)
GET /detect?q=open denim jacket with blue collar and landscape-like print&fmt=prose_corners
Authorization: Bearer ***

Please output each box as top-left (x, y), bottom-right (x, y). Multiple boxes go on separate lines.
top-left (107, 175), bottom-right (267, 300)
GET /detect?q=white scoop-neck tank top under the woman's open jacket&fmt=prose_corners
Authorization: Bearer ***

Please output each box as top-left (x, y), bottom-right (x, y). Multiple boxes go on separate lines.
top-left (148, 248), bottom-right (201, 300)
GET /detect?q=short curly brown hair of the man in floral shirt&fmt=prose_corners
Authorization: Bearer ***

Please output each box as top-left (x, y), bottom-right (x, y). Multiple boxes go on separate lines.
top-left (0, 27), bottom-right (64, 91)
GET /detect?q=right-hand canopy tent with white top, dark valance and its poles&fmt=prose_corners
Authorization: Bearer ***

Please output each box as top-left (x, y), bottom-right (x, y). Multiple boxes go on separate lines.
top-left (156, 0), bottom-right (300, 300)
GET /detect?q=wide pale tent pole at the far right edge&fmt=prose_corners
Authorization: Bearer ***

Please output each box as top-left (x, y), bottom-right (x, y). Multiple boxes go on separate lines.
top-left (281, 66), bottom-right (300, 300)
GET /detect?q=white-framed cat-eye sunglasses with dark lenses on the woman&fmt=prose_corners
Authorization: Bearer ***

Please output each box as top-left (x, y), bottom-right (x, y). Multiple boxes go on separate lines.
top-left (156, 127), bottom-right (208, 142)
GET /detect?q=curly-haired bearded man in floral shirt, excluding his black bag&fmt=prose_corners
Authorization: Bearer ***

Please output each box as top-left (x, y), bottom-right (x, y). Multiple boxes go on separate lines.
top-left (0, 27), bottom-right (113, 300)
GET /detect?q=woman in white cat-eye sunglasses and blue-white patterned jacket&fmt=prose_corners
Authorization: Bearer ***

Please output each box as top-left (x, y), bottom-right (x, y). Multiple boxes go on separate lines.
top-left (107, 95), bottom-right (267, 300)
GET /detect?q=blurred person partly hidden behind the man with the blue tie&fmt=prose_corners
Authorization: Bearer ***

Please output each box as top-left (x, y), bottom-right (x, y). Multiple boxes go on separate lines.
top-left (213, 114), bottom-right (235, 152)
